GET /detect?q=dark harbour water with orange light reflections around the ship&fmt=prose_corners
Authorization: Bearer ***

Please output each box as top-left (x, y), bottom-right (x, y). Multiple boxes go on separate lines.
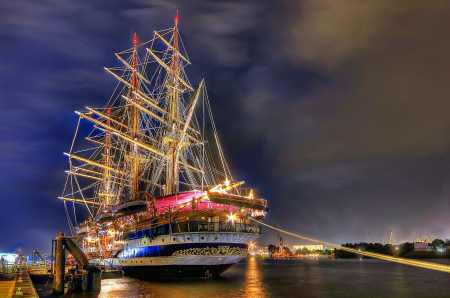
top-left (36, 258), bottom-right (450, 298)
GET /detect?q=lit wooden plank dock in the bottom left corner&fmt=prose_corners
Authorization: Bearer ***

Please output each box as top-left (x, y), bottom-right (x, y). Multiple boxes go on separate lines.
top-left (0, 270), bottom-right (39, 298)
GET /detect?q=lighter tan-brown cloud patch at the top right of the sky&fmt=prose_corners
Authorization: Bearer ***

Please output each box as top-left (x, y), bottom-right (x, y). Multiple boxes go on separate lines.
top-left (284, 0), bottom-right (446, 69)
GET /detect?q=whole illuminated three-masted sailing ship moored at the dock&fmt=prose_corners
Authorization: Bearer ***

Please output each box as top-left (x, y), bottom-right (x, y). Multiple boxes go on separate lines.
top-left (60, 12), bottom-right (268, 279)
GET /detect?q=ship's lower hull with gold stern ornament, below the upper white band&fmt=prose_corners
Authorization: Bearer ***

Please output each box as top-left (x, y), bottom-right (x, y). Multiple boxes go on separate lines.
top-left (93, 242), bottom-right (251, 280)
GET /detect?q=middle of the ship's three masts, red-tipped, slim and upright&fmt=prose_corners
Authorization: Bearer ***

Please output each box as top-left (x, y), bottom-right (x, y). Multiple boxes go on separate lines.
top-left (130, 32), bottom-right (139, 199)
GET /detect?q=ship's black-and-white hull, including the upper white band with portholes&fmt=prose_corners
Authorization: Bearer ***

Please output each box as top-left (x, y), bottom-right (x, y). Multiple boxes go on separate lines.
top-left (96, 233), bottom-right (259, 280)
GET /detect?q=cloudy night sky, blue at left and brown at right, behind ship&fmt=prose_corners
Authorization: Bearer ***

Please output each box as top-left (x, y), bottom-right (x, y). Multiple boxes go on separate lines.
top-left (0, 0), bottom-right (450, 252)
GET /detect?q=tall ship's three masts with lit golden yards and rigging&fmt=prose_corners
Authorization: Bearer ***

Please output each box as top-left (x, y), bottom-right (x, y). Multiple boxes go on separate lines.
top-left (63, 11), bottom-right (207, 213)
